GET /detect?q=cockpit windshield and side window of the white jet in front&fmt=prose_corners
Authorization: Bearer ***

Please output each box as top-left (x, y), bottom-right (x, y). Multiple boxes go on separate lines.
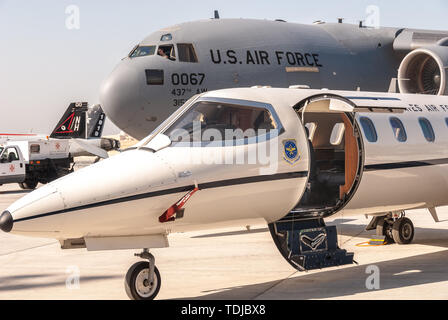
top-left (165, 101), bottom-right (277, 142)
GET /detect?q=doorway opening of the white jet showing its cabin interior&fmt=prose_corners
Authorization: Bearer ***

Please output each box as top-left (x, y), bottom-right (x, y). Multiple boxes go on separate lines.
top-left (294, 97), bottom-right (363, 217)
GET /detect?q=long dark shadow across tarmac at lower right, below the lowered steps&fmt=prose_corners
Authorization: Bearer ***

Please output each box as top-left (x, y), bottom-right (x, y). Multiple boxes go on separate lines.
top-left (181, 250), bottom-right (448, 300)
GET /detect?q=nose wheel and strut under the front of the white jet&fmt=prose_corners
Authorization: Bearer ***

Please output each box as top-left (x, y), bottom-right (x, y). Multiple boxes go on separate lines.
top-left (125, 249), bottom-right (162, 300)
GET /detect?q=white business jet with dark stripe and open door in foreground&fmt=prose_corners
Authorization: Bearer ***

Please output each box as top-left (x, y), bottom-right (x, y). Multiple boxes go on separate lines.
top-left (0, 87), bottom-right (448, 299)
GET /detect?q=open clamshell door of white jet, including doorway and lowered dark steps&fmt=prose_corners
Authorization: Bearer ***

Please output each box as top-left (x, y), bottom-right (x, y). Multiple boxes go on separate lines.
top-left (270, 93), bottom-right (405, 271)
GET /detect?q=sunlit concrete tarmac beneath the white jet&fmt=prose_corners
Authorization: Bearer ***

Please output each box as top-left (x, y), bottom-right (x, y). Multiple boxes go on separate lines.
top-left (0, 184), bottom-right (448, 300)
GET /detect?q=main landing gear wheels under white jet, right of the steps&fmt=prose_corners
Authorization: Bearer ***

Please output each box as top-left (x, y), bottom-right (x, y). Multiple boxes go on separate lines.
top-left (376, 212), bottom-right (415, 244)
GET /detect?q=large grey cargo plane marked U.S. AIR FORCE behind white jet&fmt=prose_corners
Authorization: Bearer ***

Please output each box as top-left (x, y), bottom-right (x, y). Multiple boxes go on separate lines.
top-left (100, 19), bottom-right (448, 139)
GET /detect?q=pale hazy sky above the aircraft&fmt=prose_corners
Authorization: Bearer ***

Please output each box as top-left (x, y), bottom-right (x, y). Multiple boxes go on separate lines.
top-left (0, 0), bottom-right (448, 133)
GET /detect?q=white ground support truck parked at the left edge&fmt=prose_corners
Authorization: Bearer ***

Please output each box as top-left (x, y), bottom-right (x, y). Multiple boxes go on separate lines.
top-left (0, 139), bottom-right (74, 189)
